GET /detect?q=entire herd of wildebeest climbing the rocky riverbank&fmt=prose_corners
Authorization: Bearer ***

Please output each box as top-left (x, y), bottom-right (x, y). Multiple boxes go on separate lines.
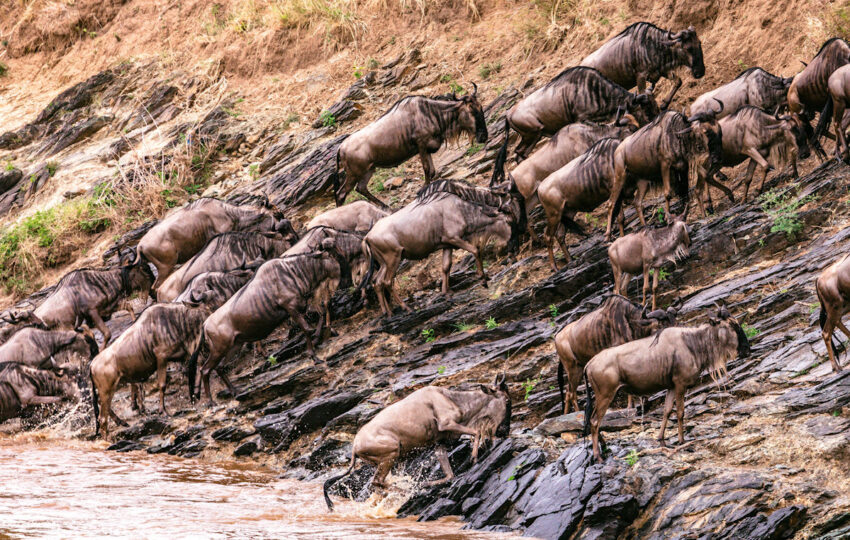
top-left (0, 22), bottom-right (850, 507)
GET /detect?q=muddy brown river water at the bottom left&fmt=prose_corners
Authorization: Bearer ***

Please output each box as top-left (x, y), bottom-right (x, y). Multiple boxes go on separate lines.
top-left (0, 434), bottom-right (507, 540)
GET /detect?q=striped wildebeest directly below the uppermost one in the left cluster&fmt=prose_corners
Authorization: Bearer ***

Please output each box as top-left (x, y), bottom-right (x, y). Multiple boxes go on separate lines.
top-left (156, 231), bottom-right (292, 302)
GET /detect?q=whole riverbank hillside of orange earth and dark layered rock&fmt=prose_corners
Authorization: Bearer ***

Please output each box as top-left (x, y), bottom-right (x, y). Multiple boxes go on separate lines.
top-left (0, 0), bottom-right (850, 538)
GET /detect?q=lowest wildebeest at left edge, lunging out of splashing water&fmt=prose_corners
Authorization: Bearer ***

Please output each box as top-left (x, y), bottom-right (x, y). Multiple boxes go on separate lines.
top-left (0, 362), bottom-right (80, 422)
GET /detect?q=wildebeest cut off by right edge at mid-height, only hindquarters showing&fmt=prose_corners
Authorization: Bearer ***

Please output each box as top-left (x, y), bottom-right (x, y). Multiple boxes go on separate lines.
top-left (815, 255), bottom-right (850, 372)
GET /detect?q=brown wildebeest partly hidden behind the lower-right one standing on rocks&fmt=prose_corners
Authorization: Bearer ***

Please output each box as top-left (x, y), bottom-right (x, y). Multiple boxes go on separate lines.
top-left (555, 294), bottom-right (678, 414)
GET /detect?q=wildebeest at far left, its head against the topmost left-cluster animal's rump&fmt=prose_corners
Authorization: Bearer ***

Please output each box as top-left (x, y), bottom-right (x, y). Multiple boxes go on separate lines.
top-left (34, 261), bottom-right (154, 346)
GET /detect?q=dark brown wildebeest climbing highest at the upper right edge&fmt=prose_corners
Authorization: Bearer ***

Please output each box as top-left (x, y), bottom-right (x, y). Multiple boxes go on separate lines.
top-left (788, 37), bottom-right (850, 158)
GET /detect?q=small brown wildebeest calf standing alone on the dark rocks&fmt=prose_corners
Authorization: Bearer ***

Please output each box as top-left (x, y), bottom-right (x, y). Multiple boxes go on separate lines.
top-left (608, 216), bottom-right (691, 310)
